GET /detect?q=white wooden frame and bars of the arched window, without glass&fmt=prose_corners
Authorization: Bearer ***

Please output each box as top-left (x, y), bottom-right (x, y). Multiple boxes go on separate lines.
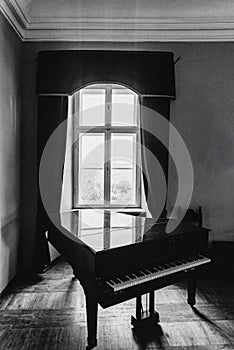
top-left (72, 84), bottom-right (141, 209)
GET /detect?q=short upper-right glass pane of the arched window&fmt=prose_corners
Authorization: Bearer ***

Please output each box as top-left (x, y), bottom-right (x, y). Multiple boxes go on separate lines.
top-left (111, 89), bottom-right (137, 125)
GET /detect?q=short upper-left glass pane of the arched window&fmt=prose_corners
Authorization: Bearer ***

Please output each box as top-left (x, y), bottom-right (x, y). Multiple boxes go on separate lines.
top-left (80, 89), bottom-right (105, 126)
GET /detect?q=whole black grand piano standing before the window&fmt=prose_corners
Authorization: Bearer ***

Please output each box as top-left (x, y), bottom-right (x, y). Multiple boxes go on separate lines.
top-left (48, 209), bottom-right (210, 349)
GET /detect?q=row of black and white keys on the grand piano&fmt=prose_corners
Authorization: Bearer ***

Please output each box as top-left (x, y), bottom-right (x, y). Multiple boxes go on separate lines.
top-left (106, 255), bottom-right (211, 292)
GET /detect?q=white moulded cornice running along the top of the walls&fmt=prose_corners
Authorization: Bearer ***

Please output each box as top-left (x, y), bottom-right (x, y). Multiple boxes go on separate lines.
top-left (0, 0), bottom-right (234, 42)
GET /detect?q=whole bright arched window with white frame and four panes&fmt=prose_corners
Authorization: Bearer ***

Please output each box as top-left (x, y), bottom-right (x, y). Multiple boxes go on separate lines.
top-left (73, 84), bottom-right (140, 208)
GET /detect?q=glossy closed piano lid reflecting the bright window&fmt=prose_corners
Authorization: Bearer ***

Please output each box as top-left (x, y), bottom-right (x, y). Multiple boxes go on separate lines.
top-left (49, 209), bottom-right (205, 251)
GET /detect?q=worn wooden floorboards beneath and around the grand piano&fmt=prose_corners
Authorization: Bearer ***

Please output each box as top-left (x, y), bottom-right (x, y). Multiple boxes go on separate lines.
top-left (0, 261), bottom-right (234, 350)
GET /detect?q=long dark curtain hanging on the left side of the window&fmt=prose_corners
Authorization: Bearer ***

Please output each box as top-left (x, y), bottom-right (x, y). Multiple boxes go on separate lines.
top-left (33, 96), bottom-right (68, 272)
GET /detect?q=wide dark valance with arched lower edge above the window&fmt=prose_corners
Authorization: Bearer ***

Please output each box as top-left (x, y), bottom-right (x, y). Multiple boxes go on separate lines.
top-left (37, 50), bottom-right (175, 98)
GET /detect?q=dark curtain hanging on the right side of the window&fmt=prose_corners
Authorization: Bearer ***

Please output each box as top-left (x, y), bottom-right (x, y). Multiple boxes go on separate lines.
top-left (140, 96), bottom-right (170, 217)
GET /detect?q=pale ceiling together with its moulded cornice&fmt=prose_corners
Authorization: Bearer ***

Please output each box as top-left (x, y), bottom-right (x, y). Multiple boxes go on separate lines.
top-left (0, 0), bottom-right (234, 41)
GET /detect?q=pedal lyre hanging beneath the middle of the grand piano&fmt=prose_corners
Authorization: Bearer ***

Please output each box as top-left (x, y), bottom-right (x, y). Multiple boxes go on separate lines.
top-left (131, 292), bottom-right (159, 332)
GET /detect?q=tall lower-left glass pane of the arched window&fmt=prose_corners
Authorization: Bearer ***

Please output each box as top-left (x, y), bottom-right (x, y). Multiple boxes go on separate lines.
top-left (77, 133), bottom-right (104, 205)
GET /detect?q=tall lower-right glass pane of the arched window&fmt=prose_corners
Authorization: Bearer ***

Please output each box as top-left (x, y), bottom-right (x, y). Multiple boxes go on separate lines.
top-left (110, 133), bottom-right (136, 205)
